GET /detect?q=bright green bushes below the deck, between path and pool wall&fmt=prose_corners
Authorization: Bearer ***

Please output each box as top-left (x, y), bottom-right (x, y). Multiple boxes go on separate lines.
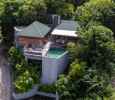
top-left (9, 47), bottom-right (40, 92)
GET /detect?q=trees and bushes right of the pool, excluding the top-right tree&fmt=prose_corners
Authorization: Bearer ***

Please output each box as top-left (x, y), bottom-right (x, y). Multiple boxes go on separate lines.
top-left (56, 23), bottom-right (115, 100)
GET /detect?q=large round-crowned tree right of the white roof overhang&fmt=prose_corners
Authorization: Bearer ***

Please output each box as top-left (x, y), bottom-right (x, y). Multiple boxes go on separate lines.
top-left (81, 26), bottom-right (115, 75)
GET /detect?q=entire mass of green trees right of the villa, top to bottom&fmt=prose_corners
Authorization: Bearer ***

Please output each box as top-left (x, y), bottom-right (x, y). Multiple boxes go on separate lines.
top-left (56, 0), bottom-right (115, 100)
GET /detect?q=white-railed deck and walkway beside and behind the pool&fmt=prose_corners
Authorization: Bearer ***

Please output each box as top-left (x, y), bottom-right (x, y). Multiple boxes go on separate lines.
top-left (23, 41), bottom-right (65, 60)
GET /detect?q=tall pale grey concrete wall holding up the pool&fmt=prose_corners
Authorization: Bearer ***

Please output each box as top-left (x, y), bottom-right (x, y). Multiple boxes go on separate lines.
top-left (41, 52), bottom-right (68, 84)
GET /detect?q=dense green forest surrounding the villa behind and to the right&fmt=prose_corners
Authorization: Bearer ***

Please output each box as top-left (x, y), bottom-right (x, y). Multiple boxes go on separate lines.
top-left (0, 0), bottom-right (115, 100)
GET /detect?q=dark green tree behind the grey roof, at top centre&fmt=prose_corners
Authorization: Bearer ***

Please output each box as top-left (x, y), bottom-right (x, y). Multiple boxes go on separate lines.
top-left (46, 0), bottom-right (75, 19)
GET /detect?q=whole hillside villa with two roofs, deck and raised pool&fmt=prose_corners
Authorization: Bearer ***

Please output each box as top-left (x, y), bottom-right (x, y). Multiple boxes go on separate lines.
top-left (15, 17), bottom-right (79, 84)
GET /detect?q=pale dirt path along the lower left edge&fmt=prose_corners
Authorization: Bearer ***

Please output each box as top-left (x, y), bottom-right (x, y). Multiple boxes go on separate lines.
top-left (0, 49), bottom-right (11, 100)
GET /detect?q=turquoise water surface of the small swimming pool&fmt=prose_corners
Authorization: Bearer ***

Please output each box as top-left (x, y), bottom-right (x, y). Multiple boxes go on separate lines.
top-left (47, 48), bottom-right (65, 58)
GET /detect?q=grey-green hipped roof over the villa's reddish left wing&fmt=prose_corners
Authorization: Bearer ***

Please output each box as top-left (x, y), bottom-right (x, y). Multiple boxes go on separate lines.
top-left (18, 21), bottom-right (50, 37)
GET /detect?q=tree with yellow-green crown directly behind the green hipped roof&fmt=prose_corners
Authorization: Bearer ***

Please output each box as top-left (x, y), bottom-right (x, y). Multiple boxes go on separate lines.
top-left (17, 0), bottom-right (47, 25)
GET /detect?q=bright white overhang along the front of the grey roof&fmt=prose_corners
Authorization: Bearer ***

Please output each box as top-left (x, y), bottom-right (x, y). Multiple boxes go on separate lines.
top-left (51, 29), bottom-right (78, 37)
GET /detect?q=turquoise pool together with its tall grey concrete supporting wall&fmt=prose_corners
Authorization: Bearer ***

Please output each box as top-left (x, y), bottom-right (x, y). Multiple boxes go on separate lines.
top-left (41, 48), bottom-right (68, 84)
